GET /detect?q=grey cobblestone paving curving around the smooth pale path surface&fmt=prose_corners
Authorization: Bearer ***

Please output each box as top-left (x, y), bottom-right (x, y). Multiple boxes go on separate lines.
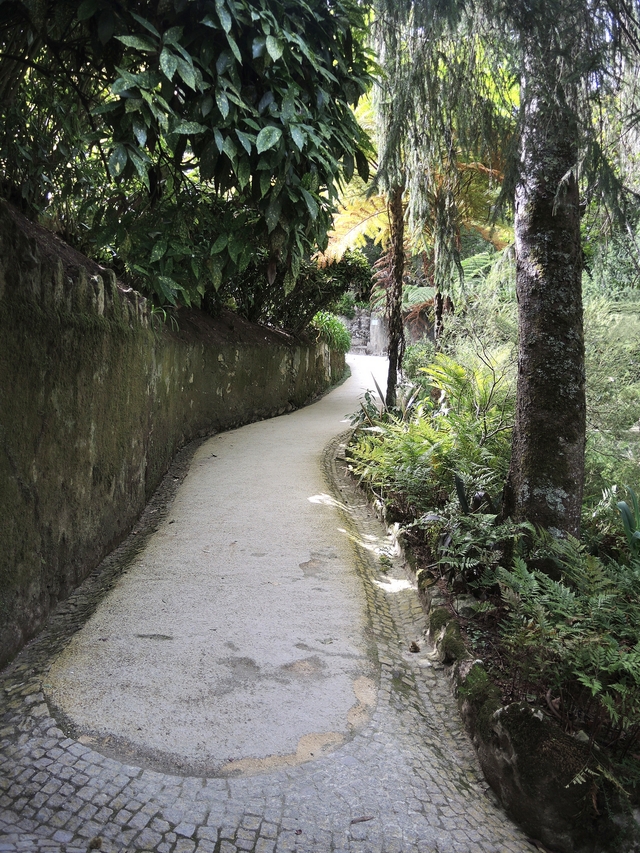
top-left (0, 436), bottom-right (534, 853)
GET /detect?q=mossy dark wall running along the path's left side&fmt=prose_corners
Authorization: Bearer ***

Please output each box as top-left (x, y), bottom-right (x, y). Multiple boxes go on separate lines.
top-left (0, 203), bottom-right (344, 666)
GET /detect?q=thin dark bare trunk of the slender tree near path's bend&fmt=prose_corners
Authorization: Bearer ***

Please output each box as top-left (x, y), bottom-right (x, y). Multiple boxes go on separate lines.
top-left (385, 186), bottom-right (404, 408)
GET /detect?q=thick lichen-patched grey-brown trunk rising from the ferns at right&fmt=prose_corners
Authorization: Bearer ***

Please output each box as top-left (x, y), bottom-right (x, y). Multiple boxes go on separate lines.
top-left (503, 43), bottom-right (585, 536)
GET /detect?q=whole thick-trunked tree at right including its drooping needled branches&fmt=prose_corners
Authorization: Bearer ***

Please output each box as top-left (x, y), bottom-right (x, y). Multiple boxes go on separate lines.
top-left (370, 0), bottom-right (639, 535)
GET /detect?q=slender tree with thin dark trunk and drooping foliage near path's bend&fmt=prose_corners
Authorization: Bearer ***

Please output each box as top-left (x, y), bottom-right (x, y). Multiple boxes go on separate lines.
top-left (374, 0), bottom-right (511, 404)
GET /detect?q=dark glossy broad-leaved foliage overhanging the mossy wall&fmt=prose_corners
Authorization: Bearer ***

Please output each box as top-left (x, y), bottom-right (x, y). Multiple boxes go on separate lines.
top-left (0, 0), bottom-right (370, 303)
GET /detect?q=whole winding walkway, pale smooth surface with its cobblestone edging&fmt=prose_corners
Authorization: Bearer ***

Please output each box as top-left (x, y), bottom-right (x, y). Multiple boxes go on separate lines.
top-left (0, 357), bottom-right (534, 853)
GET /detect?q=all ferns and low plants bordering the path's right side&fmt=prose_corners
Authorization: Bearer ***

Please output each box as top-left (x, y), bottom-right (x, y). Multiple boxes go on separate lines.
top-left (350, 246), bottom-right (640, 793)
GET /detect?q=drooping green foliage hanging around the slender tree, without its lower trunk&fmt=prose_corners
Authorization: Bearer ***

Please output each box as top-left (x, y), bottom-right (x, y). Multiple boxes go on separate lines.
top-left (374, 0), bottom-right (515, 290)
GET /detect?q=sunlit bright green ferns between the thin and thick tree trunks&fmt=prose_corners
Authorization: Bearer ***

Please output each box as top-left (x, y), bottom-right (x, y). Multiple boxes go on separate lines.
top-left (352, 250), bottom-right (515, 526)
